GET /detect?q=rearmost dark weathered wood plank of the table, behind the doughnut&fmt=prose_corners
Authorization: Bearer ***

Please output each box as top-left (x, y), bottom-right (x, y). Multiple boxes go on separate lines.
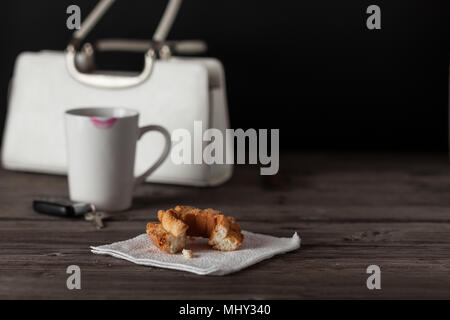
top-left (4, 155), bottom-right (450, 221)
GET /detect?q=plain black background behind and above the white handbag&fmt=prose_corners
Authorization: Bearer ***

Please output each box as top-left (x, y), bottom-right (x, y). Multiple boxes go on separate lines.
top-left (0, 0), bottom-right (450, 151)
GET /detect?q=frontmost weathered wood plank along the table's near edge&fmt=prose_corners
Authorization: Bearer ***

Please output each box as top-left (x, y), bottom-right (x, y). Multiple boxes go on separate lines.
top-left (0, 254), bottom-right (450, 299)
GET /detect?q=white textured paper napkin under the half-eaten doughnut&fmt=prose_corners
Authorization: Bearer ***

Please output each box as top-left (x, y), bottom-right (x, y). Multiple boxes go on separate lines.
top-left (91, 231), bottom-right (301, 276)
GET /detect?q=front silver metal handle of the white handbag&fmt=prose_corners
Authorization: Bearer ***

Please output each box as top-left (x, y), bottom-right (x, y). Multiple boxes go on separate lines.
top-left (65, 0), bottom-right (182, 89)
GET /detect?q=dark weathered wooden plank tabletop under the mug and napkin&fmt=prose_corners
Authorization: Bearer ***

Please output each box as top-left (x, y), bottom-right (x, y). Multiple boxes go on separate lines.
top-left (0, 153), bottom-right (450, 299)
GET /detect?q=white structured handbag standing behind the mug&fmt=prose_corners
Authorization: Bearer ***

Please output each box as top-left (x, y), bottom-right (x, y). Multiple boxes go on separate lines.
top-left (2, 0), bottom-right (233, 186)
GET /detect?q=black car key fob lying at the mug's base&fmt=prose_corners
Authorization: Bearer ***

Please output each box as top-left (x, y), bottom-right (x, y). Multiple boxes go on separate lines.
top-left (33, 198), bottom-right (92, 218)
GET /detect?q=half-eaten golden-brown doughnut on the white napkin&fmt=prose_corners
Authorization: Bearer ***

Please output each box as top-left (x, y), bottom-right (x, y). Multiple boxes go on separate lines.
top-left (147, 206), bottom-right (244, 253)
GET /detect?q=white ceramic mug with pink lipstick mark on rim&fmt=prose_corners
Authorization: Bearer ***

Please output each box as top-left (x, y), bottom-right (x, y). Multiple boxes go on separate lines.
top-left (65, 108), bottom-right (171, 211)
